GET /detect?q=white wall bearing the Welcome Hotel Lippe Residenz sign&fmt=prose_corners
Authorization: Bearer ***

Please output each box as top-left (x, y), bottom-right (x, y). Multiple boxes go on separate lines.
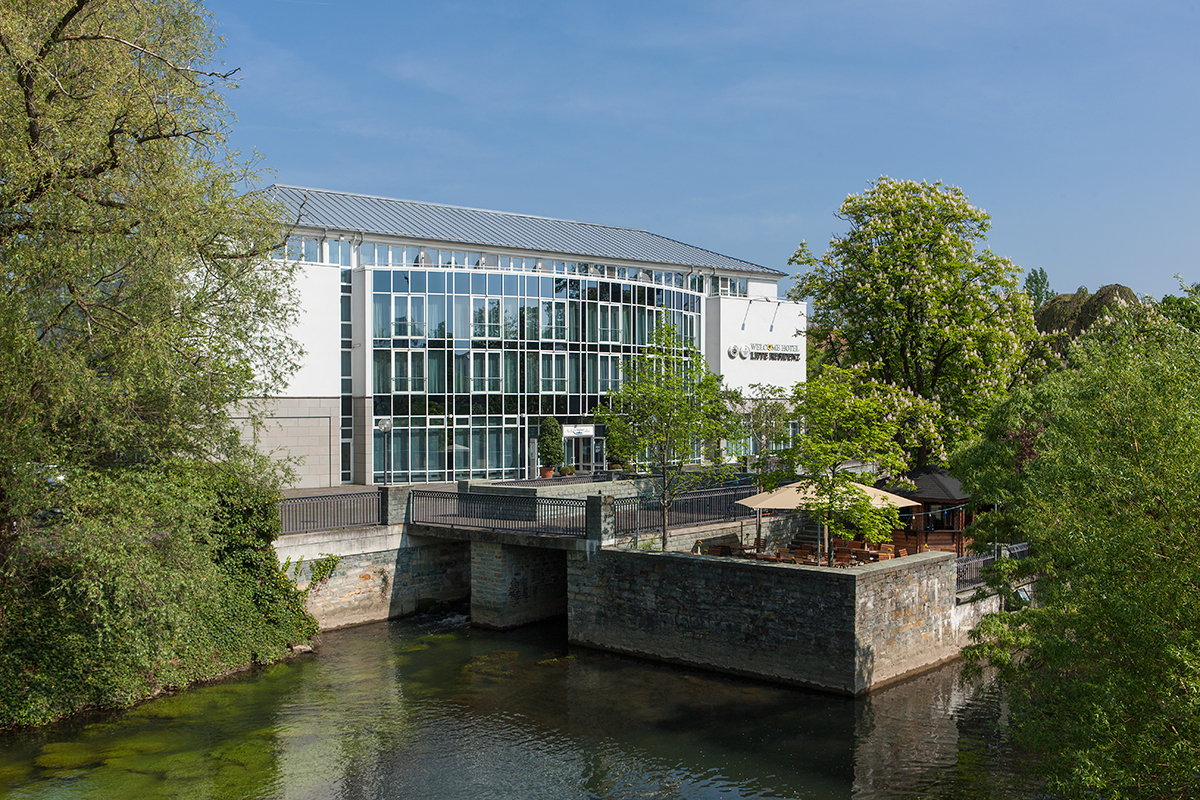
top-left (704, 297), bottom-right (808, 389)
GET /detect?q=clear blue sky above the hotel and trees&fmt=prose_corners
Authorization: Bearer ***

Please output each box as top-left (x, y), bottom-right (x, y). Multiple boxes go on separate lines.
top-left (205, 0), bottom-right (1200, 296)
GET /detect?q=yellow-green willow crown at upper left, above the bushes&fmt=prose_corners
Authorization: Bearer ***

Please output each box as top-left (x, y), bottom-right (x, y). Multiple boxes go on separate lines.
top-left (0, 0), bottom-right (295, 532)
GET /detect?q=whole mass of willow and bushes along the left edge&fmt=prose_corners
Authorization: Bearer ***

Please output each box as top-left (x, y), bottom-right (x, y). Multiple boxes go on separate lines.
top-left (0, 0), bottom-right (312, 724)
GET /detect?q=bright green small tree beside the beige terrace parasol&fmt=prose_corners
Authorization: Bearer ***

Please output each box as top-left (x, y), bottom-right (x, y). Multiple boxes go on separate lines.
top-left (770, 366), bottom-right (928, 542)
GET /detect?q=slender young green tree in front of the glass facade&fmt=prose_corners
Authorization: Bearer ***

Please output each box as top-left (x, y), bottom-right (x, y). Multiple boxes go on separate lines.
top-left (596, 324), bottom-right (731, 549)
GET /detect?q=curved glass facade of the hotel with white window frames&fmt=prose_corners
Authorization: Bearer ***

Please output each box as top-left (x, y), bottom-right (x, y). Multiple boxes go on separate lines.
top-left (286, 237), bottom-right (708, 482)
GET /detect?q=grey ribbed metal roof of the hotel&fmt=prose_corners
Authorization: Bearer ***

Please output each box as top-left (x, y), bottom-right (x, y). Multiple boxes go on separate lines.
top-left (266, 185), bottom-right (785, 277)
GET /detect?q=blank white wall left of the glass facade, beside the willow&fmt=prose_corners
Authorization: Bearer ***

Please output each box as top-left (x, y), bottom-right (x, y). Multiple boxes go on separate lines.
top-left (280, 264), bottom-right (342, 397)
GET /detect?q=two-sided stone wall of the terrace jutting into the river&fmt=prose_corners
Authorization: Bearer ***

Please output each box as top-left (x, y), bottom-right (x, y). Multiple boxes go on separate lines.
top-left (568, 549), bottom-right (959, 694)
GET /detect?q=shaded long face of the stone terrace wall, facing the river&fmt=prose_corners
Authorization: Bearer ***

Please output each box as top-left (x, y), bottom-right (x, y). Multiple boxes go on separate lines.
top-left (566, 549), bottom-right (856, 693)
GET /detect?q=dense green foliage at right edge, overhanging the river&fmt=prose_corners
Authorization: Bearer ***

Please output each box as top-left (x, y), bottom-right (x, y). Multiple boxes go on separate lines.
top-left (955, 308), bottom-right (1200, 800)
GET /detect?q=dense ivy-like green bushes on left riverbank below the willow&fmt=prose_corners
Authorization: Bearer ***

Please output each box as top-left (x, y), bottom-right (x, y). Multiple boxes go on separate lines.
top-left (0, 462), bottom-right (316, 727)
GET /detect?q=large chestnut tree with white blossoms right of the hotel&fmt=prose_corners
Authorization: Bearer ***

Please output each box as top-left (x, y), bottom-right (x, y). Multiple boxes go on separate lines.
top-left (788, 178), bottom-right (1037, 467)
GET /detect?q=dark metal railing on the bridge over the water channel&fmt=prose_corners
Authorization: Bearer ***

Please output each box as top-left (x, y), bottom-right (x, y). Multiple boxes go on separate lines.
top-left (408, 489), bottom-right (588, 539)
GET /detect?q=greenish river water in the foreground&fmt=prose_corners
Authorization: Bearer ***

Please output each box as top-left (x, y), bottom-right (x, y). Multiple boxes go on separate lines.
top-left (0, 615), bottom-right (1031, 800)
